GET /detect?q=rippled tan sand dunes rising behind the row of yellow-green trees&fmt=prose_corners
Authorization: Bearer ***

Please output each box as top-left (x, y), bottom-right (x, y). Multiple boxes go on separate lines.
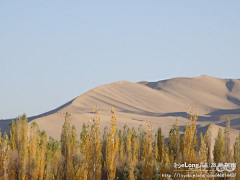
top-left (0, 75), bottom-right (240, 148)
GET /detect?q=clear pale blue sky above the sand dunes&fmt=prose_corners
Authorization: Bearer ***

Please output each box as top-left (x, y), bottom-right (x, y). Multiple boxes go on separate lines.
top-left (0, 0), bottom-right (240, 119)
